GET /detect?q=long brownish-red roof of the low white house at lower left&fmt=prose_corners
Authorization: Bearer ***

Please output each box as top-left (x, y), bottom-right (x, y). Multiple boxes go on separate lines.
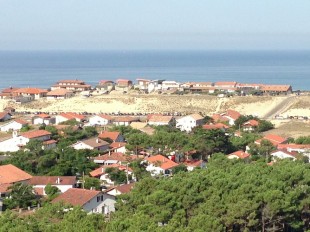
top-left (28, 176), bottom-right (76, 185)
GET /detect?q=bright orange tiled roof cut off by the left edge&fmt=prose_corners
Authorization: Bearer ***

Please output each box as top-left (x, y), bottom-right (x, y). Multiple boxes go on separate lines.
top-left (0, 164), bottom-right (32, 184)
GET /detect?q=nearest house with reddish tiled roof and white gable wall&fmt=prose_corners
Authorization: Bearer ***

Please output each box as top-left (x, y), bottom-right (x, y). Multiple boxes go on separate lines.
top-left (52, 188), bottom-right (116, 215)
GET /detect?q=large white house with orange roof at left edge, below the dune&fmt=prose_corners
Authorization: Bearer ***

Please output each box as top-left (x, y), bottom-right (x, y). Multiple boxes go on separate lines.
top-left (0, 130), bottom-right (56, 152)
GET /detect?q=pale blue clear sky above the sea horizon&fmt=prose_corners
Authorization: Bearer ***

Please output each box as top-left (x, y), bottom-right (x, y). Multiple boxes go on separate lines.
top-left (0, 0), bottom-right (310, 50)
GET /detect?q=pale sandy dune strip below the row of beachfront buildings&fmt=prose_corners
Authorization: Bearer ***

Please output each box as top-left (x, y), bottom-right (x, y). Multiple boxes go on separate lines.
top-left (0, 94), bottom-right (310, 117)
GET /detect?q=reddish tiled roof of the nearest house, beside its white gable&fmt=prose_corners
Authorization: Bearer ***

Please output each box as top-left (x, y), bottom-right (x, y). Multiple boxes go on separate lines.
top-left (52, 188), bottom-right (101, 206)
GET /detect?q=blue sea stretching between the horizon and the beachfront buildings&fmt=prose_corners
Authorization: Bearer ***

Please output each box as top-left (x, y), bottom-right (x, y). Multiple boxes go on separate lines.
top-left (0, 51), bottom-right (310, 90)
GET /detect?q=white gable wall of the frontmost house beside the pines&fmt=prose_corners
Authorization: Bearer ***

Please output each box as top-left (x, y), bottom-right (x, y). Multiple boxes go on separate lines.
top-left (83, 193), bottom-right (116, 214)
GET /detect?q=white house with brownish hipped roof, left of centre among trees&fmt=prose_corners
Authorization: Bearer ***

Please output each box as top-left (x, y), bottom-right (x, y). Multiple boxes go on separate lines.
top-left (71, 137), bottom-right (109, 151)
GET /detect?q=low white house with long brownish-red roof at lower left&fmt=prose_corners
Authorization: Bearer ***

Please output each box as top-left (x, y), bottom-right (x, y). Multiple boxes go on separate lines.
top-left (28, 176), bottom-right (76, 196)
